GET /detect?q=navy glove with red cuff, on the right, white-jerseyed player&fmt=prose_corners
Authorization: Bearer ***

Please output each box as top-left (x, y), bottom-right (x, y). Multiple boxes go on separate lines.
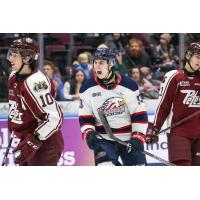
top-left (127, 132), bottom-right (146, 155)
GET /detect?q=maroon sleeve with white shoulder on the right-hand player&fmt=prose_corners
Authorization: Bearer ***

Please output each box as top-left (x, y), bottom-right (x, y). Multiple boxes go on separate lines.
top-left (154, 70), bottom-right (178, 128)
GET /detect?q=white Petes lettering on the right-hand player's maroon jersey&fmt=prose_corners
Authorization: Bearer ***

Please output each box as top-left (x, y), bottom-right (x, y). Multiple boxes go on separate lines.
top-left (181, 90), bottom-right (200, 107)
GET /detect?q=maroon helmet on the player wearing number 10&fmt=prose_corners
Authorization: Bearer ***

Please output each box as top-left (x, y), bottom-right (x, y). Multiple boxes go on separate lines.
top-left (7, 37), bottom-right (39, 61)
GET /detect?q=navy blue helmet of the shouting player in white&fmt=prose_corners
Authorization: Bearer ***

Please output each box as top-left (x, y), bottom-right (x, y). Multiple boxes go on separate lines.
top-left (92, 48), bottom-right (116, 66)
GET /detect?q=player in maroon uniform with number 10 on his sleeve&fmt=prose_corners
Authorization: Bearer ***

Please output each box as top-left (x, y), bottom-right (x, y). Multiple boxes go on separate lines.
top-left (7, 38), bottom-right (63, 166)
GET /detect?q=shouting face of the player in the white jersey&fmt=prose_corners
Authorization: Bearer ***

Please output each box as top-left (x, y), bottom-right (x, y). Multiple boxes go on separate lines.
top-left (94, 59), bottom-right (110, 79)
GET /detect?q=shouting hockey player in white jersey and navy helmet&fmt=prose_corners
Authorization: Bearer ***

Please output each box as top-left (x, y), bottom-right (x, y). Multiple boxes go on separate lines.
top-left (79, 48), bottom-right (148, 166)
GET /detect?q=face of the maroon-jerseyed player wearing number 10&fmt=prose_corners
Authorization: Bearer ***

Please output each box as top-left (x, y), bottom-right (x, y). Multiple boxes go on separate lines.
top-left (8, 52), bottom-right (23, 72)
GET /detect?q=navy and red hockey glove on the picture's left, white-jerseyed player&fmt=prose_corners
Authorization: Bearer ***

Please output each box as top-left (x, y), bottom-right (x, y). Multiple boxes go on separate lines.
top-left (83, 129), bottom-right (99, 150)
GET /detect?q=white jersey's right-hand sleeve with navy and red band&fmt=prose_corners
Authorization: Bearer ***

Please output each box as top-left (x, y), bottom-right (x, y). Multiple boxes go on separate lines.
top-left (127, 86), bottom-right (148, 134)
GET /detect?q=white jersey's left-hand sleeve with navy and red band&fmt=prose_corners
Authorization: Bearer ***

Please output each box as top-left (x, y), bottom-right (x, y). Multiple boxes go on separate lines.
top-left (79, 92), bottom-right (95, 133)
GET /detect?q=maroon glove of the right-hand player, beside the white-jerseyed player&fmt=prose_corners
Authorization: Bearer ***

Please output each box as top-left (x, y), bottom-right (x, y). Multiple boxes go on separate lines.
top-left (146, 122), bottom-right (160, 144)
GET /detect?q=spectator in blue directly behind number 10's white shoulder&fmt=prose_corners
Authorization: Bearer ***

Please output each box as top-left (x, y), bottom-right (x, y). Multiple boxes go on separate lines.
top-left (43, 60), bottom-right (64, 101)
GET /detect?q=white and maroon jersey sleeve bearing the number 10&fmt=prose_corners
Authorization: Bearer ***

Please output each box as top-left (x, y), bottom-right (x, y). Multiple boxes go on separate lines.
top-left (22, 75), bottom-right (63, 140)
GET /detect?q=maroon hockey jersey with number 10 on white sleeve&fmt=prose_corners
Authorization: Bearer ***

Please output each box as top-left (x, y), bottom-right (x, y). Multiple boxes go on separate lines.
top-left (8, 71), bottom-right (63, 140)
